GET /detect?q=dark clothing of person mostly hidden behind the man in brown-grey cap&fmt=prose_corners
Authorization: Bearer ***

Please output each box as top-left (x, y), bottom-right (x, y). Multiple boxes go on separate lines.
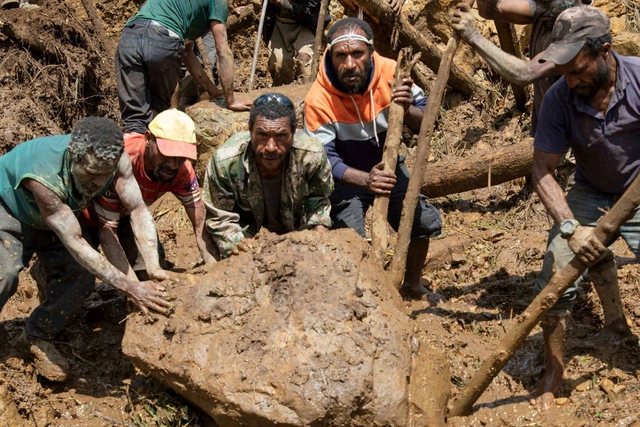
top-left (529, 0), bottom-right (560, 136)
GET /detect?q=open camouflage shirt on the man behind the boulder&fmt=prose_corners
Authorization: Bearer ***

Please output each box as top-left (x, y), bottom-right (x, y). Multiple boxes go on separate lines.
top-left (203, 130), bottom-right (333, 257)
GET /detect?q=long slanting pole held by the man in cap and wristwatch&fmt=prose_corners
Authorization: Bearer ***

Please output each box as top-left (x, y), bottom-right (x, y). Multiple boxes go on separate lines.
top-left (449, 172), bottom-right (640, 417)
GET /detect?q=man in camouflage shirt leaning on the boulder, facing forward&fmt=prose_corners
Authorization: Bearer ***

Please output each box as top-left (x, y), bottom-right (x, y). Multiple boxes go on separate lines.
top-left (203, 93), bottom-right (333, 257)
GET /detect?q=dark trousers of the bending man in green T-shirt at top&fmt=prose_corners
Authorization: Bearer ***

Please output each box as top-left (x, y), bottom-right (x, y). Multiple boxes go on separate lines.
top-left (115, 19), bottom-right (184, 133)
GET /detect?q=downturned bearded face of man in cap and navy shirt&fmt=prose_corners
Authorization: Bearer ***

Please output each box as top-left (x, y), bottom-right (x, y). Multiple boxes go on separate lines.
top-left (556, 45), bottom-right (610, 100)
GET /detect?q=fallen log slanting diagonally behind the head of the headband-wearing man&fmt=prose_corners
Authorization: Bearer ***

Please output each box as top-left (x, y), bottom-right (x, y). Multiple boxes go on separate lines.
top-left (340, 0), bottom-right (480, 96)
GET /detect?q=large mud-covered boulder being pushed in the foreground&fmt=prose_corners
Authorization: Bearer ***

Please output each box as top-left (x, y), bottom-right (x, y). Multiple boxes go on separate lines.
top-left (122, 230), bottom-right (449, 427)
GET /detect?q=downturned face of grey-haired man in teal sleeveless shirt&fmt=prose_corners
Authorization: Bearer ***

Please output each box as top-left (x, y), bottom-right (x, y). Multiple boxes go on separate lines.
top-left (71, 153), bottom-right (118, 201)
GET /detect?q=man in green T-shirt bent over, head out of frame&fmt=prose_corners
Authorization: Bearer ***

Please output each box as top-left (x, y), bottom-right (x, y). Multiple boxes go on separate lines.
top-left (116, 0), bottom-right (250, 133)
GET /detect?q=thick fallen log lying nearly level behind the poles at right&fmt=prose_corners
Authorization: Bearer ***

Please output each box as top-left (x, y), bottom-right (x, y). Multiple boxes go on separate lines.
top-left (420, 138), bottom-right (533, 197)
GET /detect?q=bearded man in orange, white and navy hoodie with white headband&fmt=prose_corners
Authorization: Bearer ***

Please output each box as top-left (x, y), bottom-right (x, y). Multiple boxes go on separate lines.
top-left (305, 18), bottom-right (442, 298)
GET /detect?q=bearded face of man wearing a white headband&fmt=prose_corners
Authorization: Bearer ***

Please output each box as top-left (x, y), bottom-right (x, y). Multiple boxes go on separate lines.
top-left (331, 29), bottom-right (371, 94)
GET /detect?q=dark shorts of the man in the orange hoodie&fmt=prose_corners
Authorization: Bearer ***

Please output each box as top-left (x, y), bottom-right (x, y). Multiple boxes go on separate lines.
top-left (331, 159), bottom-right (442, 240)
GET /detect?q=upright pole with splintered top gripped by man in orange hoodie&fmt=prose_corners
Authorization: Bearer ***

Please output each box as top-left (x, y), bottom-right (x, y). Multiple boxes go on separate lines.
top-left (371, 47), bottom-right (420, 265)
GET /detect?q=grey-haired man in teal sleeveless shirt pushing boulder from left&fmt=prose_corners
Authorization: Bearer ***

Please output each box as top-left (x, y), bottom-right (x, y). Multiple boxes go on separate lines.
top-left (0, 117), bottom-right (172, 381)
